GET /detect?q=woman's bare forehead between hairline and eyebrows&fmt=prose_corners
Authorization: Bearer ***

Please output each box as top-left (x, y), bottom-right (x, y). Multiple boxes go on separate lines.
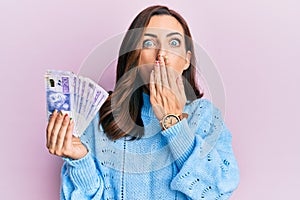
top-left (146, 15), bottom-right (184, 35)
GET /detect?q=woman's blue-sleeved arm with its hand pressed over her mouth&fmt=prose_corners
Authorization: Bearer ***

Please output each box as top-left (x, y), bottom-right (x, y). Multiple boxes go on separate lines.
top-left (150, 54), bottom-right (239, 199)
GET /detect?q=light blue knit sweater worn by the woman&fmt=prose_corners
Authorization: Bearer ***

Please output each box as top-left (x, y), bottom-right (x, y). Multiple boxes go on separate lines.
top-left (61, 94), bottom-right (239, 200)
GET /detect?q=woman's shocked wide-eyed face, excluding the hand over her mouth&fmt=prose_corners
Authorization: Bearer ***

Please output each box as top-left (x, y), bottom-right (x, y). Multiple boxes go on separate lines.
top-left (139, 15), bottom-right (191, 85)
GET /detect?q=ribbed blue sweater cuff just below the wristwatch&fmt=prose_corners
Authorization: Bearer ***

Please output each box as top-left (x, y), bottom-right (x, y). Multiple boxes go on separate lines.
top-left (162, 119), bottom-right (195, 168)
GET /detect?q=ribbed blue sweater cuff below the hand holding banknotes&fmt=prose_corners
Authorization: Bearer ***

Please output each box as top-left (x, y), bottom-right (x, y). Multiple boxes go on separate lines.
top-left (63, 152), bottom-right (100, 190)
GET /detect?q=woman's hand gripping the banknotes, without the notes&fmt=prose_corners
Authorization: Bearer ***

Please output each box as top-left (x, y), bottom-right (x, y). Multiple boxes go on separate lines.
top-left (46, 110), bottom-right (88, 160)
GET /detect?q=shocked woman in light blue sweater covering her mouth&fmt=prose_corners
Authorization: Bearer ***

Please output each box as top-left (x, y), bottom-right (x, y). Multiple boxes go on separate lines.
top-left (47, 6), bottom-right (239, 200)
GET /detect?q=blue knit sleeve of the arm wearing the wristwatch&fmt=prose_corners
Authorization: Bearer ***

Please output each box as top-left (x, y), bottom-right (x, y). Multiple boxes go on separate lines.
top-left (162, 101), bottom-right (239, 199)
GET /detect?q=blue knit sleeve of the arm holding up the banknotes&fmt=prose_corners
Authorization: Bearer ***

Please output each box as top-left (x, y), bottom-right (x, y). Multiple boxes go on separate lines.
top-left (60, 118), bottom-right (103, 200)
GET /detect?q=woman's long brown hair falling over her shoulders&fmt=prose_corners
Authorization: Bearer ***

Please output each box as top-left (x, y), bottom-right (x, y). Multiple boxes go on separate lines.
top-left (99, 5), bottom-right (203, 140)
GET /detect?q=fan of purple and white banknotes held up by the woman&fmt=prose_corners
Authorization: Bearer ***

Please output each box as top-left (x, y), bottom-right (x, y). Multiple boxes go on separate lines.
top-left (45, 70), bottom-right (108, 137)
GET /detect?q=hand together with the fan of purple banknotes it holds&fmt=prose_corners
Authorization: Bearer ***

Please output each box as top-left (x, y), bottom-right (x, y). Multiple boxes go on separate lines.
top-left (45, 70), bottom-right (108, 159)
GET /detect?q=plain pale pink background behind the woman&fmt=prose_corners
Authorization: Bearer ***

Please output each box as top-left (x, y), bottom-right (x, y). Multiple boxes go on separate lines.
top-left (0, 0), bottom-right (300, 200)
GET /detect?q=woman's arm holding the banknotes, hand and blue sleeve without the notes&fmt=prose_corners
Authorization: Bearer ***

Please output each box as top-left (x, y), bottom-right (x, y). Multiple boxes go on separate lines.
top-left (47, 111), bottom-right (103, 200)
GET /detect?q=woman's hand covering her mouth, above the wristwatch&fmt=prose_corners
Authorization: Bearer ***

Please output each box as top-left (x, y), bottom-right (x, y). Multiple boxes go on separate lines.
top-left (149, 56), bottom-right (186, 120)
